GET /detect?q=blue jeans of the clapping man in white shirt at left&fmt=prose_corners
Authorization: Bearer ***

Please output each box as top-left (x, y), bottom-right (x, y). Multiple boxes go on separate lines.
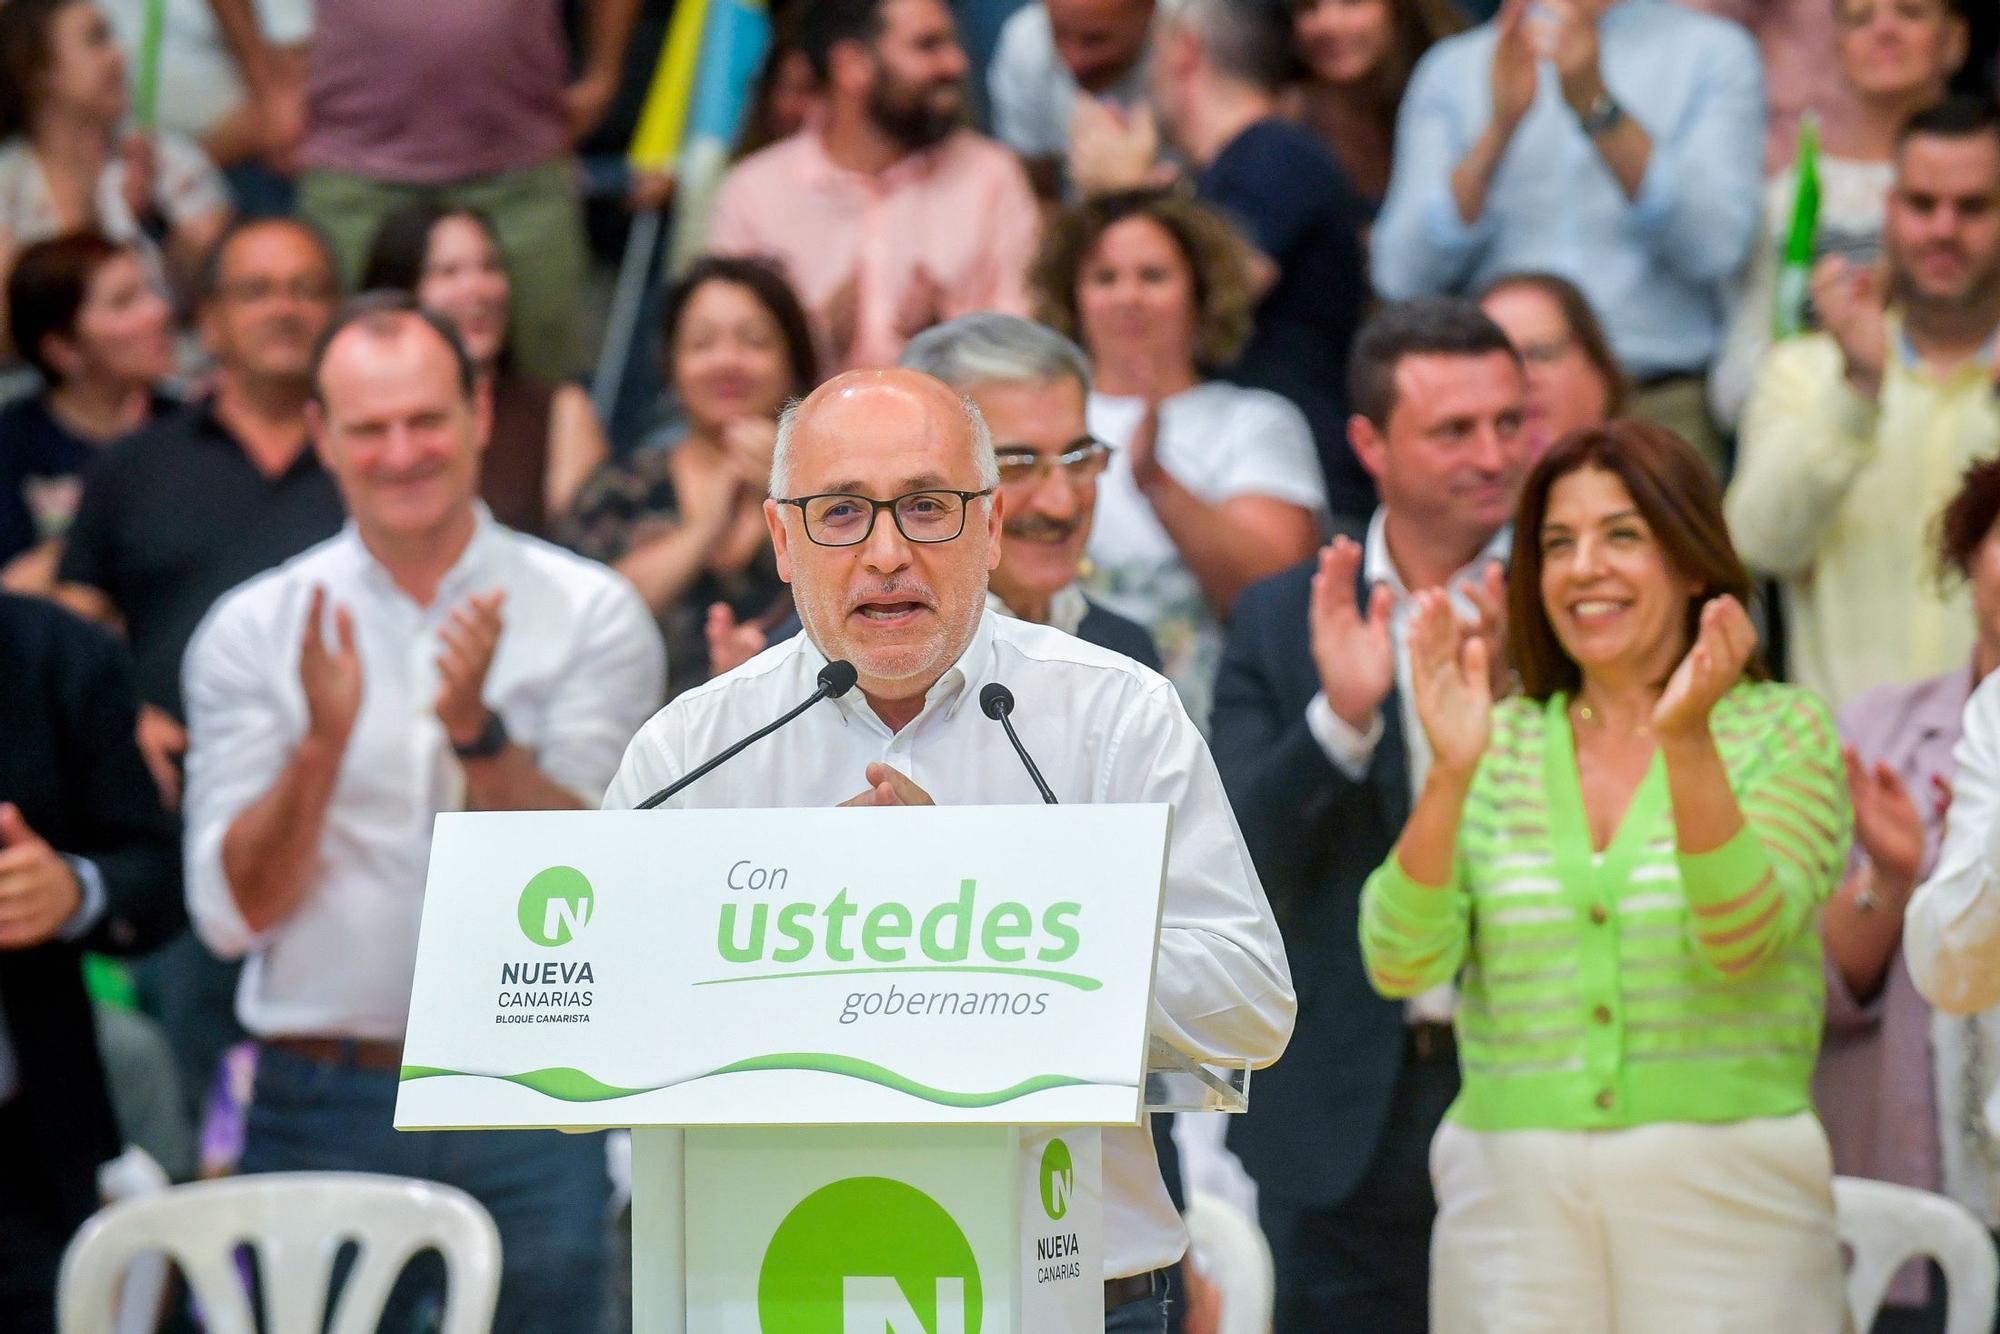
top-left (242, 1046), bottom-right (610, 1334)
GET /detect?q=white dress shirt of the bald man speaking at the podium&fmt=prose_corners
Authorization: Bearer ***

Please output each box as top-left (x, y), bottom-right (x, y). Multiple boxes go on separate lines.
top-left (604, 612), bottom-right (1296, 1278)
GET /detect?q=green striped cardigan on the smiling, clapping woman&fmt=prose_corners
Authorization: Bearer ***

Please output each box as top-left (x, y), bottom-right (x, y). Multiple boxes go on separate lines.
top-left (1360, 682), bottom-right (1852, 1130)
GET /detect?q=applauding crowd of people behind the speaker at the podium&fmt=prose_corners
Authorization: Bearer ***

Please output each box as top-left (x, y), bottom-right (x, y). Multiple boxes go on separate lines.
top-left (11, 0), bottom-right (2000, 1332)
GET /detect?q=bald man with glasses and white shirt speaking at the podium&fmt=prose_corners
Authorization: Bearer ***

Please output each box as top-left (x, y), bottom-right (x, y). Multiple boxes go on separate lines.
top-left (604, 370), bottom-right (1296, 1332)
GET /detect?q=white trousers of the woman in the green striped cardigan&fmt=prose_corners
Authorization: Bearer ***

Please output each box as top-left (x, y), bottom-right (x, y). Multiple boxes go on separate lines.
top-left (1430, 1112), bottom-right (1848, 1334)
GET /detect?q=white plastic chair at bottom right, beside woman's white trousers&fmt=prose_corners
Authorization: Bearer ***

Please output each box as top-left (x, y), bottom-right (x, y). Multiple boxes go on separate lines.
top-left (1834, 1176), bottom-right (2000, 1334)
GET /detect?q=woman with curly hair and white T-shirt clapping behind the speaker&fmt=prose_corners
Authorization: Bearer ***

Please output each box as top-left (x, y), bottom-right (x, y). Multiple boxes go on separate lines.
top-left (1032, 190), bottom-right (1326, 726)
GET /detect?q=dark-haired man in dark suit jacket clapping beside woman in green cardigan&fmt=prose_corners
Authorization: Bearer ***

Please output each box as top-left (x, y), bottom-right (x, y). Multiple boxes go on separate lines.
top-left (1212, 300), bottom-right (1528, 1334)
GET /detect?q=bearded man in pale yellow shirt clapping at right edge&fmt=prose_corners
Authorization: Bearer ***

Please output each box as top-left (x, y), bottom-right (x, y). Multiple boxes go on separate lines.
top-left (1728, 98), bottom-right (2000, 706)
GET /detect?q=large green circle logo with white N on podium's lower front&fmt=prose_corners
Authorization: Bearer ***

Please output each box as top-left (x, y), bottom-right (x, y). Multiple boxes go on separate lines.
top-left (756, 1176), bottom-right (984, 1334)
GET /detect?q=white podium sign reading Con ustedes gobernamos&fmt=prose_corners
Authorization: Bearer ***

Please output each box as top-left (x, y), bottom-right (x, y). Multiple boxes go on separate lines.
top-left (396, 806), bottom-right (1168, 1130)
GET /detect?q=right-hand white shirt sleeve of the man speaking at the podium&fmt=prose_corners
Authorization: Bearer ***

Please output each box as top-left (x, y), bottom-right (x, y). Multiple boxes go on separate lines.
top-left (1094, 680), bottom-right (1298, 1066)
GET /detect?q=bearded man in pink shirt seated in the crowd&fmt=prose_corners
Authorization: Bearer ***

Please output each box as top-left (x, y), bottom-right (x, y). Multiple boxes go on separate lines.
top-left (708, 0), bottom-right (1040, 370)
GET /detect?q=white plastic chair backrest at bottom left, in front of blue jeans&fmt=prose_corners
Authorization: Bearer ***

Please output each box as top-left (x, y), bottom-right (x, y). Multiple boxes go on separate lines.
top-left (58, 1172), bottom-right (500, 1334)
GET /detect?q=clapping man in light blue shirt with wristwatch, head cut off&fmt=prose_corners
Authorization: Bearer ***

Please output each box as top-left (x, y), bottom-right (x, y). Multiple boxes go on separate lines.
top-left (1370, 0), bottom-right (1764, 470)
